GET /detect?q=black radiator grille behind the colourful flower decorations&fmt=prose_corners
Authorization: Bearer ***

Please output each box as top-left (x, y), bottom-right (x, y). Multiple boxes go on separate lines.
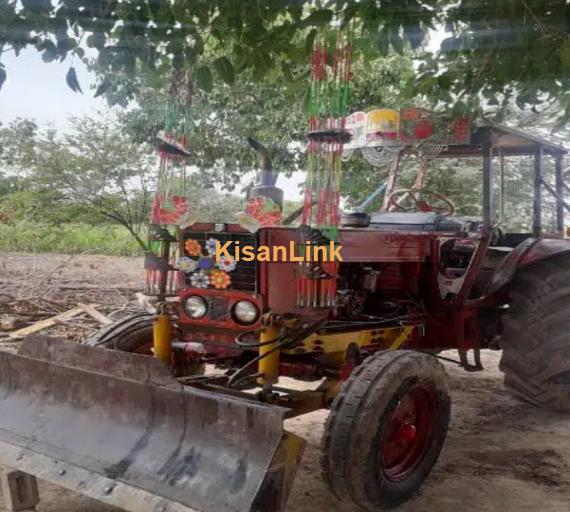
top-left (184, 230), bottom-right (258, 292)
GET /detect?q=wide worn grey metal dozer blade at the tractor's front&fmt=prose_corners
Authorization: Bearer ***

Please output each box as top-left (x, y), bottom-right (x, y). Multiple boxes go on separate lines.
top-left (0, 336), bottom-right (304, 512)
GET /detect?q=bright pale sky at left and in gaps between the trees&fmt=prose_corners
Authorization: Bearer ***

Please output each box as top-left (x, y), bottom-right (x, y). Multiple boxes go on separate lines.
top-left (0, 49), bottom-right (304, 201)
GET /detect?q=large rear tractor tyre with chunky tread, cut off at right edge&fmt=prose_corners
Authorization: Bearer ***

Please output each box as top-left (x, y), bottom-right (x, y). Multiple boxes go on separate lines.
top-left (500, 254), bottom-right (570, 412)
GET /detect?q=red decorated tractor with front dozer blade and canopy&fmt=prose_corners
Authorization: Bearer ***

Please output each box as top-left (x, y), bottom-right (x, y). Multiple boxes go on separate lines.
top-left (0, 127), bottom-right (570, 512)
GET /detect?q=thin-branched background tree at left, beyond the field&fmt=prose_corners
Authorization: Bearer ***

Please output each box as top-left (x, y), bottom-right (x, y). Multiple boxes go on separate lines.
top-left (0, 117), bottom-right (155, 247)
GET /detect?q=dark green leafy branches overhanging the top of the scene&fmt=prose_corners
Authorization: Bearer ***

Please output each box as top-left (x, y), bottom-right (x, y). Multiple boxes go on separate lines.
top-left (4, 0), bottom-right (570, 123)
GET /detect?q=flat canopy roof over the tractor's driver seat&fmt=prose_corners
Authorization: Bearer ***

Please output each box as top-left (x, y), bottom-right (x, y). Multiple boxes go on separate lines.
top-left (439, 125), bottom-right (568, 158)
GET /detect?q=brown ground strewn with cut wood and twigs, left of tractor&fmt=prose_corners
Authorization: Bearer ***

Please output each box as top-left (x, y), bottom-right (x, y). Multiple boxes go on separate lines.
top-left (0, 255), bottom-right (149, 348)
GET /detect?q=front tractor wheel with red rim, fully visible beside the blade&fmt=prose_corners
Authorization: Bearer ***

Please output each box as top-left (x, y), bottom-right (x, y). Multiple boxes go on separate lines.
top-left (321, 350), bottom-right (451, 511)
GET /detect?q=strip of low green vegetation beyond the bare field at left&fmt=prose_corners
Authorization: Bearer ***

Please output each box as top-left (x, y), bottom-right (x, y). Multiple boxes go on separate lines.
top-left (0, 221), bottom-right (142, 256)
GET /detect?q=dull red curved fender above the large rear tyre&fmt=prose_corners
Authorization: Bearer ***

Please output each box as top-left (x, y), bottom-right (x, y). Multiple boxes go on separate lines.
top-left (485, 238), bottom-right (570, 296)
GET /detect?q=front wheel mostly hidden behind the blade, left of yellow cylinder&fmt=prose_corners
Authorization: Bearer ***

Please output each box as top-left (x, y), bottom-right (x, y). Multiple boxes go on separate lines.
top-left (85, 313), bottom-right (154, 355)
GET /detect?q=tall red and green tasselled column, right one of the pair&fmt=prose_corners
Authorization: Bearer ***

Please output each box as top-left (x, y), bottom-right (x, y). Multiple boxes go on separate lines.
top-left (297, 28), bottom-right (352, 307)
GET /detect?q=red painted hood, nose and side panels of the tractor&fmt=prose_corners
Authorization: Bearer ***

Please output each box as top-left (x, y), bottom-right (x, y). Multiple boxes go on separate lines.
top-left (179, 224), bottom-right (502, 352)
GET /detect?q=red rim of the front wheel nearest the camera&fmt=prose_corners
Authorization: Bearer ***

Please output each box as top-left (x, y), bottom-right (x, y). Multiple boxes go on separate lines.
top-left (380, 385), bottom-right (437, 482)
